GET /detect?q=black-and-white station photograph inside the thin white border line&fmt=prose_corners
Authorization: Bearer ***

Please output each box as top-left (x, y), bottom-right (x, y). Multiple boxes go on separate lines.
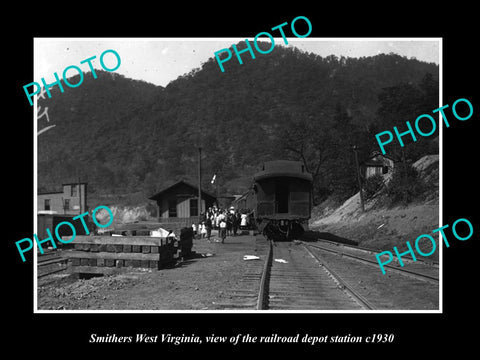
top-left (32, 37), bottom-right (442, 312)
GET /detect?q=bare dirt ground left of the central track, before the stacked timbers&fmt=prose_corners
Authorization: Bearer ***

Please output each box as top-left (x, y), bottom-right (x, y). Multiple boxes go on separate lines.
top-left (37, 235), bottom-right (261, 310)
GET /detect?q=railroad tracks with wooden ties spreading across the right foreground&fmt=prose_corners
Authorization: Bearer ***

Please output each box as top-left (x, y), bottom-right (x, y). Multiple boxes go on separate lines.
top-left (216, 238), bottom-right (439, 311)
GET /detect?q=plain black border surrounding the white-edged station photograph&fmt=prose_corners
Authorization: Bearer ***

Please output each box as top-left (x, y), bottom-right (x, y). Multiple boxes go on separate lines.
top-left (6, 2), bottom-right (480, 356)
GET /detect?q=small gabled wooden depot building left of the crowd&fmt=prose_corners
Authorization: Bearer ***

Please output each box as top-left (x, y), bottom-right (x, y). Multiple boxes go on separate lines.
top-left (149, 180), bottom-right (216, 227)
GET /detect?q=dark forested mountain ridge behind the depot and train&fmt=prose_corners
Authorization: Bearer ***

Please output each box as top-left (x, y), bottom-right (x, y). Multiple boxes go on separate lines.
top-left (38, 44), bottom-right (438, 205)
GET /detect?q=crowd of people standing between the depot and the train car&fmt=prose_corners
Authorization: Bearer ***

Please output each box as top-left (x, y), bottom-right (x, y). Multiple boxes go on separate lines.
top-left (192, 206), bottom-right (253, 243)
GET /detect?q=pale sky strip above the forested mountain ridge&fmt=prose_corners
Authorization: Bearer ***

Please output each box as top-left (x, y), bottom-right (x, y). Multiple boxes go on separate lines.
top-left (32, 37), bottom-right (441, 86)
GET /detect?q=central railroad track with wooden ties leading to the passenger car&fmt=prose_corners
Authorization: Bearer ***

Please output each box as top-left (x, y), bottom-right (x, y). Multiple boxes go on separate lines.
top-left (216, 237), bottom-right (373, 310)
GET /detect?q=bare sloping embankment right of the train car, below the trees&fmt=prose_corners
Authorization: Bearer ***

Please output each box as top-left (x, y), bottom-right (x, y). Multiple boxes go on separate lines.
top-left (310, 155), bottom-right (439, 260)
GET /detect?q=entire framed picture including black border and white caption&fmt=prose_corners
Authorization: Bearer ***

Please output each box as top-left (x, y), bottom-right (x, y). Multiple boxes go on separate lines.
top-left (4, 8), bottom-right (478, 356)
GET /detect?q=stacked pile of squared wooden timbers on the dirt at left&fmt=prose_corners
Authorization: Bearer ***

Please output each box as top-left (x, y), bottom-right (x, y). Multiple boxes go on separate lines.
top-left (62, 236), bottom-right (177, 274)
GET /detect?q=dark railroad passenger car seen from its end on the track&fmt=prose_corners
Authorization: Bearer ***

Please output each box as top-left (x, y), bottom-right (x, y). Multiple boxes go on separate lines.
top-left (253, 160), bottom-right (313, 240)
